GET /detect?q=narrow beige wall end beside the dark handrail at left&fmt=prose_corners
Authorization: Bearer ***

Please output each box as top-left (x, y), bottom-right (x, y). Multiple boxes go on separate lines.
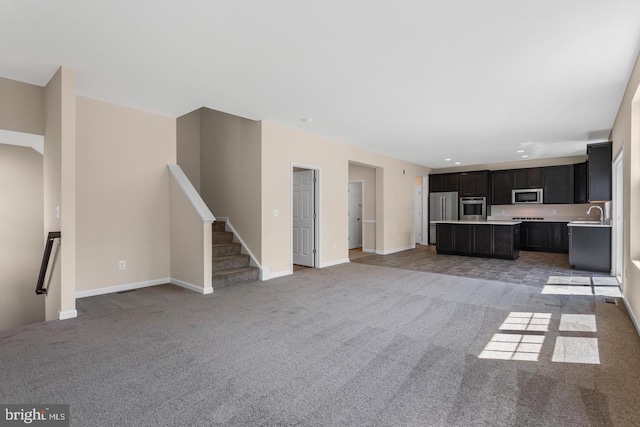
top-left (43, 67), bottom-right (76, 320)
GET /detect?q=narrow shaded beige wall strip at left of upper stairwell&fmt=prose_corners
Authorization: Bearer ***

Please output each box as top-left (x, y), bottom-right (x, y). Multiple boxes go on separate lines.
top-left (176, 110), bottom-right (201, 193)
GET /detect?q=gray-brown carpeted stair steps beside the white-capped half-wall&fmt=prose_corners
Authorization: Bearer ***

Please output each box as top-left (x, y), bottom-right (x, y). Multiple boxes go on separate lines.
top-left (211, 221), bottom-right (260, 289)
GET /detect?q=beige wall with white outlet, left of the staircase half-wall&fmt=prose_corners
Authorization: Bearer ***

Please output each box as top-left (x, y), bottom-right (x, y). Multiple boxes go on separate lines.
top-left (75, 97), bottom-right (176, 291)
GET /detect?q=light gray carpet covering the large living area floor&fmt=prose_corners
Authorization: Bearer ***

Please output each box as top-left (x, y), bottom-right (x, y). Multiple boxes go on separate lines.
top-left (0, 264), bottom-right (640, 426)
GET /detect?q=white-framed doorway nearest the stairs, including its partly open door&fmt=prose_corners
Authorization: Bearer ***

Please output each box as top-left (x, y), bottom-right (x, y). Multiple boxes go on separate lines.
top-left (291, 165), bottom-right (320, 272)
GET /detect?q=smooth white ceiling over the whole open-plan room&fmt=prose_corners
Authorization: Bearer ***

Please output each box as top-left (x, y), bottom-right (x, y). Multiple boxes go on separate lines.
top-left (0, 0), bottom-right (640, 168)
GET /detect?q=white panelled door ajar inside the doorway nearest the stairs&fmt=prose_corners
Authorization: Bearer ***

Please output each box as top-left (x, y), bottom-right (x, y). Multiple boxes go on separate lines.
top-left (291, 170), bottom-right (315, 267)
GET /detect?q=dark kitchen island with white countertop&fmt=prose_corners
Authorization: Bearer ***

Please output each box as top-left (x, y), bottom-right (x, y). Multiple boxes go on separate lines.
top-left (435, 220), bottom-right (521, 260)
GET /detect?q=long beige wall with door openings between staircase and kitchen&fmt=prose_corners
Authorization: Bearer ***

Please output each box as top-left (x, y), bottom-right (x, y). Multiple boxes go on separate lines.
top-left (260, 122), bottom-right (429, 276)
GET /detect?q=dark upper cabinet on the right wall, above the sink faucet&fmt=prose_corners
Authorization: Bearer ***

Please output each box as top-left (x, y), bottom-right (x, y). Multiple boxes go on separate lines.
top-left (587, 142), bottom-right (611, 203)
